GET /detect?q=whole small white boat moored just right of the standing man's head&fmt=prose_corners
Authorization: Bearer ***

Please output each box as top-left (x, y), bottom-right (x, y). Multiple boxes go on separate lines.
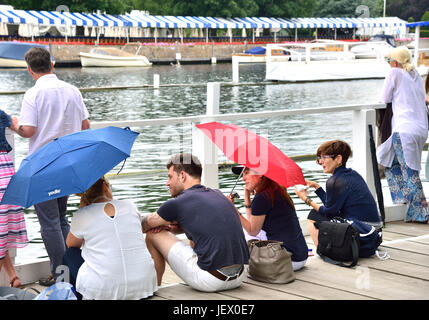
top-left (79, 48), bottom-right (152, 67)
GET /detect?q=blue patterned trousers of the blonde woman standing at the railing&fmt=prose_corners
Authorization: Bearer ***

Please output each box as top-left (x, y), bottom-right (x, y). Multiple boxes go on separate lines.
top-left (385, 132), bottom-right (429, 222)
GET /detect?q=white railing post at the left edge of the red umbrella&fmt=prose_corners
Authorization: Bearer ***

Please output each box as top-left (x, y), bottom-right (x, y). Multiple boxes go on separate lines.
top-left (192, 82), bottom-right (220, 189)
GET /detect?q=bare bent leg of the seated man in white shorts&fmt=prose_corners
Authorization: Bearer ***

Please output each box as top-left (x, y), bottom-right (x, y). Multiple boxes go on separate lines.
top-left (146, 230), bottom-right (180, 286)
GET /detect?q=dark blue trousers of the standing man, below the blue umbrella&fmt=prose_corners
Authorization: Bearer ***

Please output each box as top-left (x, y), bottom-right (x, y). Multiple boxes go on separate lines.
top-left (34, 196), bottom-right (70, 278)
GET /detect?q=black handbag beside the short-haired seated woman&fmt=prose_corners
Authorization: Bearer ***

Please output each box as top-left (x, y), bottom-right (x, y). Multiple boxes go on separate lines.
top-left (314, 221), bottom-right (360, 268)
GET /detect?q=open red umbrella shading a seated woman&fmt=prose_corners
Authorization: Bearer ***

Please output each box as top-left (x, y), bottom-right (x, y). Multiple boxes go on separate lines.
top-left (196, 122), bottom-right (305, 188)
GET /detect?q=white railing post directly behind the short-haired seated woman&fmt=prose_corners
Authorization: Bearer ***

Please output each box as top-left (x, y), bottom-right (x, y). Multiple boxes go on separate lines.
top-left (352, 109), bottom-right (377, 199)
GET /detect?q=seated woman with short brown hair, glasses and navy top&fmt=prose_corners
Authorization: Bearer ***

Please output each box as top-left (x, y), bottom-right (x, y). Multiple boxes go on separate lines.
top-left (295, 140), bottom-right (382, 246)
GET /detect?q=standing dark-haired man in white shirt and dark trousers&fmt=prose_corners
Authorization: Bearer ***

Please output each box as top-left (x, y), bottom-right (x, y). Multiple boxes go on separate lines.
top-left (10, 47), bottom-right (90, 285)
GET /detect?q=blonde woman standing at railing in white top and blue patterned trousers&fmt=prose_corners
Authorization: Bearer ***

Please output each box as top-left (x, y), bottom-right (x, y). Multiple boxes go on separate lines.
top-left (377, 46), bottom-right (429, 223)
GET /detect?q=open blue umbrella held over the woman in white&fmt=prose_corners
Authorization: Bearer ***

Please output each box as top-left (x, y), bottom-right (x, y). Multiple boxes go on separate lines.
top-left (1, 127), bottom-right (139, 208)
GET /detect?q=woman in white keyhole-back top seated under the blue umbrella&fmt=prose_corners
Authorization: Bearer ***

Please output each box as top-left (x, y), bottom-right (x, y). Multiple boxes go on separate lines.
top-left (63, 177), bottom-right (158, 300)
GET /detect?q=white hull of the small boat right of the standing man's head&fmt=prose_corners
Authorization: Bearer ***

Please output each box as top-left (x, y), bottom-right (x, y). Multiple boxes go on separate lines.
top-left (79, 52), bottom-right (152, 67)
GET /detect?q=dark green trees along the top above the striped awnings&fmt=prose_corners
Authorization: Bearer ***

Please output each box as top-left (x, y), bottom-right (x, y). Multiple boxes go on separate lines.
top-left (0, 0), bottom-right (429, 21)
